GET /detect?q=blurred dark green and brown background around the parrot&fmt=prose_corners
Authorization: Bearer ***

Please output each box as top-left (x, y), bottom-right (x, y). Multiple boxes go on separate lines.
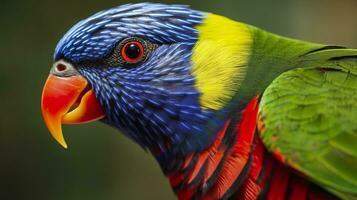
top-left (0, 0), bottom-right (357, 200)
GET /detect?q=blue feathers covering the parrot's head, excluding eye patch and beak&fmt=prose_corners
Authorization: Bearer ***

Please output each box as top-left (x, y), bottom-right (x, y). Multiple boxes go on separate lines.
top-left (54, 3), bottom-right (222, 169)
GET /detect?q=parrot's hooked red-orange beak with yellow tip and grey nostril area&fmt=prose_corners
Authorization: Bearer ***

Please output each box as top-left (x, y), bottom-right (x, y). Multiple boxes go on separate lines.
top-left (41, 61), bottom-right (105, 148)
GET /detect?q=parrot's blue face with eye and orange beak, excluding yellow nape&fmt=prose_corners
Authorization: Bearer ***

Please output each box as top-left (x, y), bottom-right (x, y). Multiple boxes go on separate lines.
top-left (42, 3), bottom-right (216, 155)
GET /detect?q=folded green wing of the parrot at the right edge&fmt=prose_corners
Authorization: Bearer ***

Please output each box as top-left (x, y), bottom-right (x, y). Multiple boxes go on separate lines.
top-left (259, 49), bottom-right (357, 199)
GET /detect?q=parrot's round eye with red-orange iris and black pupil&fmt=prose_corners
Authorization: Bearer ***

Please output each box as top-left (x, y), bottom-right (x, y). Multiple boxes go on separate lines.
top-left (120, 41), bottom-right (145, 64)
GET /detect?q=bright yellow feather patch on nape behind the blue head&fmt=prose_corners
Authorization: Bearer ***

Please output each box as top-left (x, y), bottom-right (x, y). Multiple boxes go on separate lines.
top-left (192, 14), bottom-right (252, 110)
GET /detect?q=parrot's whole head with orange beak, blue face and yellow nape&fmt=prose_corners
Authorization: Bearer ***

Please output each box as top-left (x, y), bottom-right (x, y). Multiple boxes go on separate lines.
top-left (41, 3), bottom-right (250, 161)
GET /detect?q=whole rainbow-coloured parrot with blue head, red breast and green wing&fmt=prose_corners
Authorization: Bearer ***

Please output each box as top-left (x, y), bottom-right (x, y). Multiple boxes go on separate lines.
top-left (41, 3), bottom-right (357, 200)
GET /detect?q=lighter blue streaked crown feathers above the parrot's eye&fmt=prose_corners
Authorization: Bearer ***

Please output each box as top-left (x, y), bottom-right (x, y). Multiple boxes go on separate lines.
top-left (55, 3), bottom-right (204, 62)
